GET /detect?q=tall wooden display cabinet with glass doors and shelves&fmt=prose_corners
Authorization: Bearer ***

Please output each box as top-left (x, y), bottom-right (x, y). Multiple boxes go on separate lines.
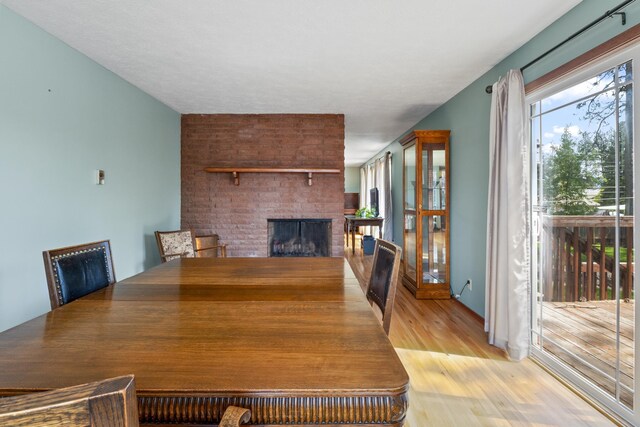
top-left (400, 130), bottom-right (451, 299)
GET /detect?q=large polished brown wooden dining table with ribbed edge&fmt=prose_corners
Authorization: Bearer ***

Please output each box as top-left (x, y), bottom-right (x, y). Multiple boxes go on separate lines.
top-left (0, 258), bottom-right (409, 426)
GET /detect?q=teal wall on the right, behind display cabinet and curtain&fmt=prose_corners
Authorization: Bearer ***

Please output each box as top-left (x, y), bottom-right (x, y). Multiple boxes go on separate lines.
top-left (366, 0), bottom-right (640, 316)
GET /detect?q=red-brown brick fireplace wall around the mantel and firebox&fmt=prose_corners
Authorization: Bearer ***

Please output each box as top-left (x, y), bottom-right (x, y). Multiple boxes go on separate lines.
top-left (181, 114), bottom-right (344, 257)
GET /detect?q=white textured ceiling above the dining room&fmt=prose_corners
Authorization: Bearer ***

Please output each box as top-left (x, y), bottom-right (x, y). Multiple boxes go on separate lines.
top-left (0, 0), bottom-right (579, 166)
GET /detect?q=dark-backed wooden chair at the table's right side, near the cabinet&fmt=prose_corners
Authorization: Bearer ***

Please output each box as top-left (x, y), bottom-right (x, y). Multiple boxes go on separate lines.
top-left (367, 239), bottom-right (402, 335)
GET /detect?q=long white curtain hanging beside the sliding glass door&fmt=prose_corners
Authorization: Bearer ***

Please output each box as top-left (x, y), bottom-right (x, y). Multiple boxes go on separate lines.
top-left (485, 70), bottom-right (531, 360)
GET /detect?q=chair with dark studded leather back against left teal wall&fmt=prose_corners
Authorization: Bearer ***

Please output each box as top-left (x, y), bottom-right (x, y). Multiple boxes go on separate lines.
top-left (42, 240), bottom-right (116, 309)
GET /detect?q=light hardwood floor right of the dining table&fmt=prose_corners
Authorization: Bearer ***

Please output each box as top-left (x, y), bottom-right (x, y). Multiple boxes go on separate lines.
top-left (345, 237), bottom-right (615, 427)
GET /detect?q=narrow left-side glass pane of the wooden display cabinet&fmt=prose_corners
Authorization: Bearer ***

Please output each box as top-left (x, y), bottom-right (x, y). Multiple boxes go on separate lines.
top-left (403, 144), bottom-right (418, 283)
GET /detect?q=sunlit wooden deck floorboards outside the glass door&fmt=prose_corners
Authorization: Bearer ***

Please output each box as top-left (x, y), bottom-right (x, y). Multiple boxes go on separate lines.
top-left (542, 300), bottom-right (635, 406)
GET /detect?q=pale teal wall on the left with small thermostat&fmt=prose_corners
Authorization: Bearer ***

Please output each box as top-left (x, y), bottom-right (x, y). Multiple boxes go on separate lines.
top-left (0, 6), bottom-right (180, 331)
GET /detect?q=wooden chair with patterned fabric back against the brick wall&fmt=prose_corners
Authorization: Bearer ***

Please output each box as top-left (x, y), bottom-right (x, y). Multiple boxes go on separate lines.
top-left (156, 229), bottom-right (227, 262)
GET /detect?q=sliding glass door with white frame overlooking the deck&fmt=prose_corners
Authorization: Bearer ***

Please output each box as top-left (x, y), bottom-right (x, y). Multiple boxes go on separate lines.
top-left (529, 44), bottom-right (640, 422)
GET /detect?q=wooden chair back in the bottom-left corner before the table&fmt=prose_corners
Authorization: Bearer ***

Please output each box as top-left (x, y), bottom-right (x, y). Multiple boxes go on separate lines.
top-left (0, 375), bottom-right (139, 427)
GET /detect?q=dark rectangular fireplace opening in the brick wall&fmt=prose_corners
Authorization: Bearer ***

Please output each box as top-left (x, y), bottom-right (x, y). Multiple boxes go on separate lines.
top-left (267, 219), bottom-right (331, 257)
